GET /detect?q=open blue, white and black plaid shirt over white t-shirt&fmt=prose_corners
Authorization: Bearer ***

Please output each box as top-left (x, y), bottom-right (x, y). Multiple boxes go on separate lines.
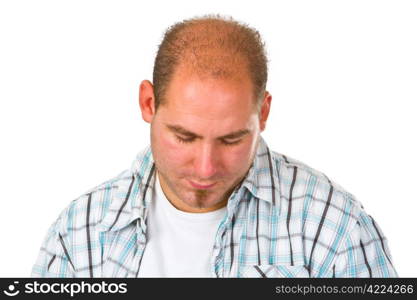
top-left (31, 138), bottom-right (398, 277)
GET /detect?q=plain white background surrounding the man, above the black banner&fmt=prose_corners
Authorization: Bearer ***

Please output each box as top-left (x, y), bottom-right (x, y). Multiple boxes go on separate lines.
top-left (0, 0), bottom-right (417, 277)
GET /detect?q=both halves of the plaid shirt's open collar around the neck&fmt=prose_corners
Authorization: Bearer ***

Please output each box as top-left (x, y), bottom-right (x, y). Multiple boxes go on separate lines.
top-left (98, 136), bottom-right (279, 231)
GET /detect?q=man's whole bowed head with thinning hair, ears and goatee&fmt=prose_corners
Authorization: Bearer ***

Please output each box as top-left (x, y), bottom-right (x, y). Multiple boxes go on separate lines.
top-left (139, 16), bottom-right (271, 212)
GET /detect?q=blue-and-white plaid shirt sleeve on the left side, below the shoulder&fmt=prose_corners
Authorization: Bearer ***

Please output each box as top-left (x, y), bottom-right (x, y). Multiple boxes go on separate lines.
top-left (31, 209), bottom-right (75, 277)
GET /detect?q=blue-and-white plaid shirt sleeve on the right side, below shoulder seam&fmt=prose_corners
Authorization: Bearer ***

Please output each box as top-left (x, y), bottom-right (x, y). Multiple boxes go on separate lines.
top-left (333, 210), bottom-right (398, 278)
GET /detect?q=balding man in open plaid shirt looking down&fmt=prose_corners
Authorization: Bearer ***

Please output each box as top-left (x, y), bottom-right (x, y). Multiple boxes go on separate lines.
top-left (32, 16), bottom-right (397, 277)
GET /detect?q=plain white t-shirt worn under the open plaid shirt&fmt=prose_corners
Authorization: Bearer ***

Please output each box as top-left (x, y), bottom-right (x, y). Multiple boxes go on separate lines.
top-left (138, 175), bottom-right (226, 277)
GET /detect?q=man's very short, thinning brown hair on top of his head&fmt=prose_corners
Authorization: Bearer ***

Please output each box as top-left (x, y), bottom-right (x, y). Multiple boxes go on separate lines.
top-left (153, 15), bottom-right (268, 111)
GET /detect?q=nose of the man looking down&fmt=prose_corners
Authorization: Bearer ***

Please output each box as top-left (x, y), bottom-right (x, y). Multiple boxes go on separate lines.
top-left (194, 143), bottom-right (219, 180)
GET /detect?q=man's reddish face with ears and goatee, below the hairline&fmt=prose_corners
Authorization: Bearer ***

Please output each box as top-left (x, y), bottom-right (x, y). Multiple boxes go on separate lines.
top-left (139, 68), bottom-right (272, 213)
